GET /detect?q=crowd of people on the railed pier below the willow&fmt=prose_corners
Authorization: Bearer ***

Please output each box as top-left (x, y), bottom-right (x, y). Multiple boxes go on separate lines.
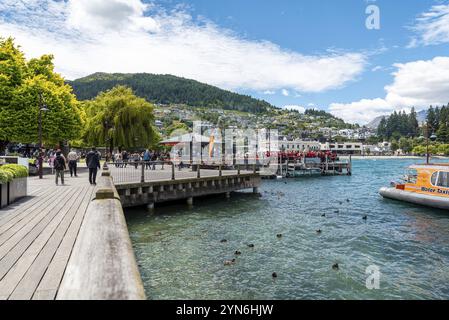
top-left (112, 149), bottom-right (170, 170)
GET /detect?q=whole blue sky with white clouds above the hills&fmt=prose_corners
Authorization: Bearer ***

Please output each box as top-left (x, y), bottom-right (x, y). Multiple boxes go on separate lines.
top-left (0, 0), bottom-right (449, 124)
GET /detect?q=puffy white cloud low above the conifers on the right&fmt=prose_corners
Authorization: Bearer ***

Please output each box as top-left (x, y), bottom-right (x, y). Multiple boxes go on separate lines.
top-left (329, 57), bottom-right (449, 124)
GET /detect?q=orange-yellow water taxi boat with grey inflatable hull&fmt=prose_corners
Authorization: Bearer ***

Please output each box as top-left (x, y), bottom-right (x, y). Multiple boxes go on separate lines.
top-left (379, 164), bottom-right (449, 210)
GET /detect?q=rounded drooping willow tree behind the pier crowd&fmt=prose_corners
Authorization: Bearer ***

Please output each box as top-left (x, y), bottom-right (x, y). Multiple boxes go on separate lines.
top-left (84, 86), bottom-right (158, 153)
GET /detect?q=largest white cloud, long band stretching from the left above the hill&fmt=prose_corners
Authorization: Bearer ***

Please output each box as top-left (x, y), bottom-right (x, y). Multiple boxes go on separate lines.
top-left (0, 0), bottom-right (366, 92)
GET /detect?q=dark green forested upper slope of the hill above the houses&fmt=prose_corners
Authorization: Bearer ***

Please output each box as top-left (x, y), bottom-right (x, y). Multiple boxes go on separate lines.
top-left (67, 73), bottom-right (274, 113)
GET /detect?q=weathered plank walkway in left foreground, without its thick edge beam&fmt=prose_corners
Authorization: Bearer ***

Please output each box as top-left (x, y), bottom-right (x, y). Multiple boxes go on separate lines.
top-left (0, 173), bottom-right (96, 300)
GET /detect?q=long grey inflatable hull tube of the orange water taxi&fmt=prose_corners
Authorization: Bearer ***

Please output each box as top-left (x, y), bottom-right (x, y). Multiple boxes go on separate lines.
top-left (379, 188), bottom-right (449, 210)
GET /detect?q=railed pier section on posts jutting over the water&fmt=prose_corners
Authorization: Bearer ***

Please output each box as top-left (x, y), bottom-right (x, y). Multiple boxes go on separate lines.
top-left (109, 163), bottom-right (261, 210)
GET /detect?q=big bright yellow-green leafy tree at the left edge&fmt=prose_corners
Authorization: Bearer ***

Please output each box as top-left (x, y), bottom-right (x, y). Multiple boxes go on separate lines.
top-left (0, 38), bottom-right (83, 150)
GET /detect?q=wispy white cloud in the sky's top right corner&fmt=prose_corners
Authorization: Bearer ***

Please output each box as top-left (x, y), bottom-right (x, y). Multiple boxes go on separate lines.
top-left (408, 3), bottom-right (449, 48)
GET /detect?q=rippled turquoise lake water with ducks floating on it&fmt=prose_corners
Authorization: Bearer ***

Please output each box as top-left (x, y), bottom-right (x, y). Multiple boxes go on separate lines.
top-left (127, 160), bottom-right (449, 299)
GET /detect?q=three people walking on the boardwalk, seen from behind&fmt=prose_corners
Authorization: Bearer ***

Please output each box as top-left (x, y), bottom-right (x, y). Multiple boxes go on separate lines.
top-left (52, 147), bottom-right (101, 185)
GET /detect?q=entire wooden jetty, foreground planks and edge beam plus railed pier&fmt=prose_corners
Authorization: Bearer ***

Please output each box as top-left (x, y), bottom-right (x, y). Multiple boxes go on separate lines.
top-left (0, 163), bottom-right (260, 300)
